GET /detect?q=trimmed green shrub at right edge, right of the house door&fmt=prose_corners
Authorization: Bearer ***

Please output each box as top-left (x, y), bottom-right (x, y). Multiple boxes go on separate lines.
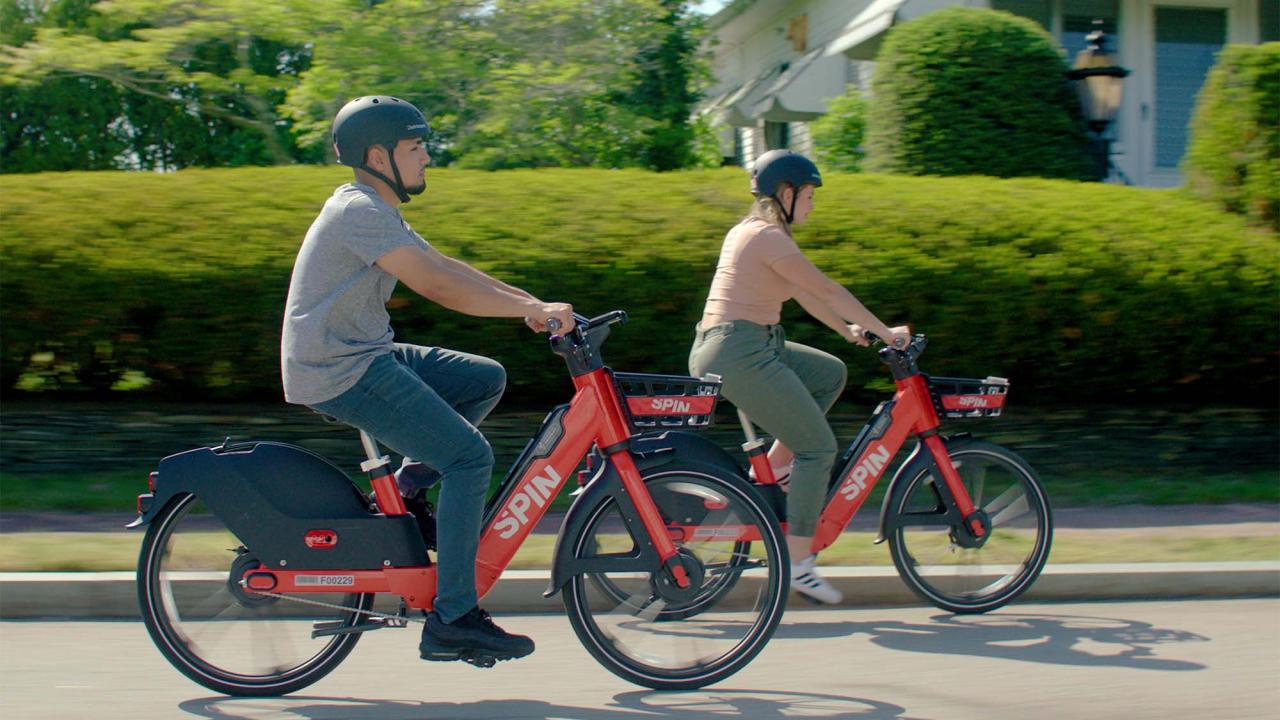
top-left (1184, 42), bottom-right (1280, 231)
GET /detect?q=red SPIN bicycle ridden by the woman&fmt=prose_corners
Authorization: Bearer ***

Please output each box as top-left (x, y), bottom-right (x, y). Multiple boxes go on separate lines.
top-left (739, 334), bottom-right (1053, 612)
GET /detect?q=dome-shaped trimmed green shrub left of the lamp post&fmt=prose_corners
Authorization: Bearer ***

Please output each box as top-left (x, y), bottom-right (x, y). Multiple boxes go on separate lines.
top-left (865, 8), bottom-right (1096, 179)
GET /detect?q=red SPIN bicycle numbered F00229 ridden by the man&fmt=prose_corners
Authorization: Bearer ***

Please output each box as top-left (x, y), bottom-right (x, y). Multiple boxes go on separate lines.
top-left (131, 311), bottom-right (788, 696)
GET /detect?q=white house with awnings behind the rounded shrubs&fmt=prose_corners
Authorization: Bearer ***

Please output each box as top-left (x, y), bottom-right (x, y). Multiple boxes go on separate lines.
top-left (704, 0), bottom-right (1280, 187)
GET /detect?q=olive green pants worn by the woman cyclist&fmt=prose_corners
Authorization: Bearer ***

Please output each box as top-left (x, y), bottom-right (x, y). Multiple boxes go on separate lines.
top-left (689, 320), bottom-right (847, 537)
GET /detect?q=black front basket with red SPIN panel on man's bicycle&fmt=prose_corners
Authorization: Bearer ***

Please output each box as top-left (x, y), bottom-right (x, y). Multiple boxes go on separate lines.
top-left (613, 373), bottom-right (721, 430)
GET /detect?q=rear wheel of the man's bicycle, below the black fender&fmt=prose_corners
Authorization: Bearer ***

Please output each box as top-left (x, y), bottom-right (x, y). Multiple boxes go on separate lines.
top-left (137, 493), bottom-right (374, 696)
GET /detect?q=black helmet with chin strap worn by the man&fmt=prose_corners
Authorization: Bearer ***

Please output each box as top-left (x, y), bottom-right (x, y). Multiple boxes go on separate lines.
top-left (333, 95), bottom-right (431, 202)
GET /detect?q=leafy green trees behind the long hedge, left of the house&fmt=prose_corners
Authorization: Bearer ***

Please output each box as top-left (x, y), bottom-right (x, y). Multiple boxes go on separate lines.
top-left (0, 0), bottom-right (707, 172)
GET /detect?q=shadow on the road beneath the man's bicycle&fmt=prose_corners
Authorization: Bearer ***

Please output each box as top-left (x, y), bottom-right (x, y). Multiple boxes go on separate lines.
top-left (178, 688), bottom-right (920, 720)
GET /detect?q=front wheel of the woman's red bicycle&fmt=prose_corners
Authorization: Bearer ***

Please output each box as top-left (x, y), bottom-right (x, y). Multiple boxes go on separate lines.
top-left (888, 439), bottom-right (1053, 614)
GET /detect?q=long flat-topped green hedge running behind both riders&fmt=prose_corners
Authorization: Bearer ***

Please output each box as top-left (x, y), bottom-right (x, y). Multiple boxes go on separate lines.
top-left (0, 167), bottom-right (1280, 402)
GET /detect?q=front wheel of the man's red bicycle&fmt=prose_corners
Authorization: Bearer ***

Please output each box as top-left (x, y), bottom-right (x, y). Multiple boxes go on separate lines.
top-left (564, 465), bottom-right (787, 689)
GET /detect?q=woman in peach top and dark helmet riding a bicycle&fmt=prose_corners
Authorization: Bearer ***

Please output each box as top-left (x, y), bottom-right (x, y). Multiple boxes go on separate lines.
top-left (689, 150), bottom-right (910, 603)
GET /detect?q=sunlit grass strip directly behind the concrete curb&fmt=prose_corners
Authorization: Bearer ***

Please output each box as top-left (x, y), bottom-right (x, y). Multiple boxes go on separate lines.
top-left (0, 530), bottom-right (1280, 573)
